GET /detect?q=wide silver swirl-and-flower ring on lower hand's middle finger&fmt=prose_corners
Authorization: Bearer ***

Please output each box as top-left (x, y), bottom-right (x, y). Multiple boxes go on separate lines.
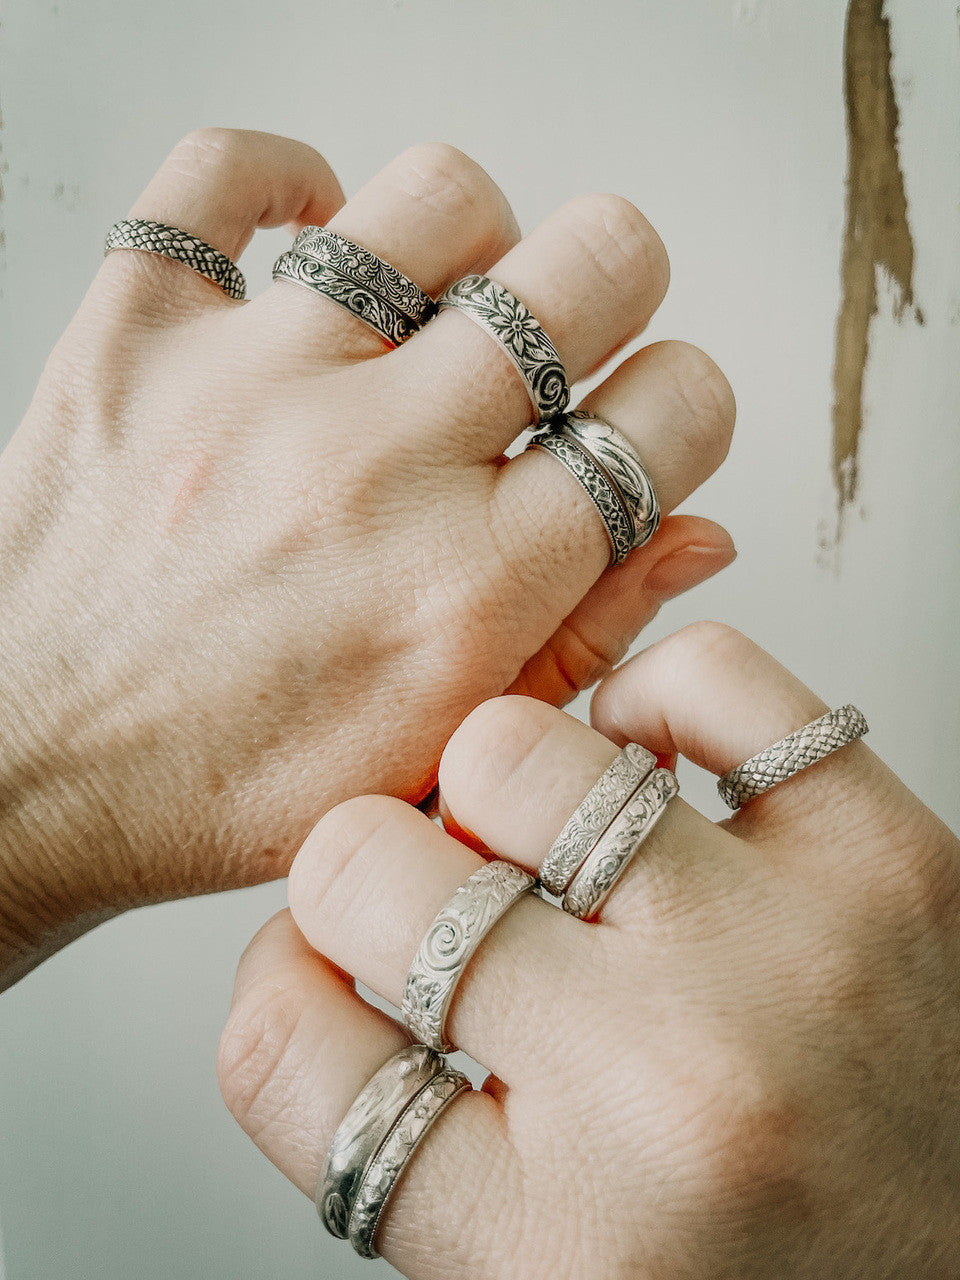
top-left (401, 861), bottom-right (536, 1053)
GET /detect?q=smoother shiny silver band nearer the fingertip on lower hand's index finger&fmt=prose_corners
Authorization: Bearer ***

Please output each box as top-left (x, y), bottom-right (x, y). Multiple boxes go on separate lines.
top-left (315, 1044), bottom-right (444, 1240)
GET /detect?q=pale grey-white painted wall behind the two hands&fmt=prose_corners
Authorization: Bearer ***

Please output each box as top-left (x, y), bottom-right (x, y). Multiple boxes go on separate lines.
top-left (0, 0), bottom-right (960, 1280)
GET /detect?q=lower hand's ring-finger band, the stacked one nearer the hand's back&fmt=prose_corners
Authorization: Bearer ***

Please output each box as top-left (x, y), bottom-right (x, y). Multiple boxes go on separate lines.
top-left (563, 769), bottom-right (680, 920)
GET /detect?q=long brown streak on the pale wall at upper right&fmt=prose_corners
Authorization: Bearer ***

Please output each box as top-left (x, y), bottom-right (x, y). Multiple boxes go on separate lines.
top-left (833, 0), bottom-right (923, 529)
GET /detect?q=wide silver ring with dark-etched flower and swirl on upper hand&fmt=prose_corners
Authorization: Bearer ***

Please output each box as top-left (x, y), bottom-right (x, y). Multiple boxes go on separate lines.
top-left (439, 275), bottom-right (570, 422)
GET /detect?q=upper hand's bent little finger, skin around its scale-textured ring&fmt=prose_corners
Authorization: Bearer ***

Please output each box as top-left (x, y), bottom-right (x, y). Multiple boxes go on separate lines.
top-left (102, 129), bottom-right (343, 305)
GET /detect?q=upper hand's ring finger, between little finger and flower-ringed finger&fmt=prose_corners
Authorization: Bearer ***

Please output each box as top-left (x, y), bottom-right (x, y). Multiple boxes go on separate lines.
top-left (248, 142), bottom-right (520, 361)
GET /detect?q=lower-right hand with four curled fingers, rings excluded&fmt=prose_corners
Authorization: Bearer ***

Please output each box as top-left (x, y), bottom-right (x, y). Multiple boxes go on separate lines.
top-left (220, 623), bottom-right (960, 1280)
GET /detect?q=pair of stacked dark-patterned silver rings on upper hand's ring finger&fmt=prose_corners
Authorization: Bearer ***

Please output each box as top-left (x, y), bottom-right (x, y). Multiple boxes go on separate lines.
top-left (273, 227), bottom-right (436, 347)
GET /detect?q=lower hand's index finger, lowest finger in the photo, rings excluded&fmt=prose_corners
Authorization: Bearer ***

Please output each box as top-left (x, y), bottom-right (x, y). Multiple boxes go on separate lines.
top-left (218, 911), bottom-right (513, 1275)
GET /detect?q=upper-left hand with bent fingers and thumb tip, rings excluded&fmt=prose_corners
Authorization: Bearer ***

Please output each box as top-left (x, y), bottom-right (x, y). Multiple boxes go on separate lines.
top-left (0, 129), bottom-right (733, 984)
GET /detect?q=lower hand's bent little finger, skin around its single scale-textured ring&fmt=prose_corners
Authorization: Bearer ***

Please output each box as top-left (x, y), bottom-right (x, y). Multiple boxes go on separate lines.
top-left (591, 622), bottom-right (886, 829)
